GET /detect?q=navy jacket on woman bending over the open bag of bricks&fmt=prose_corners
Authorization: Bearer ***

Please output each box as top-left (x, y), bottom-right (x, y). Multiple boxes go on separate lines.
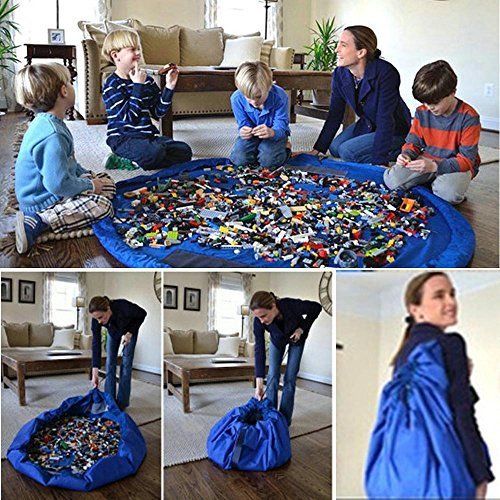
top-left (92, 299), bottom-right (148, 368)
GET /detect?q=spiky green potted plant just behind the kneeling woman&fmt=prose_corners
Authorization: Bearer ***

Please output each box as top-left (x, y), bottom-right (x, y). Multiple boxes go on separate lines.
top-left (304, 17), bottom-right (341, 107)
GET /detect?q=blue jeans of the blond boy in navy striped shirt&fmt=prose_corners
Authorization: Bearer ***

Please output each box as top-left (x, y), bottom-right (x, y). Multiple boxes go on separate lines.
top-left (109, 136), bottom-right (193, 170)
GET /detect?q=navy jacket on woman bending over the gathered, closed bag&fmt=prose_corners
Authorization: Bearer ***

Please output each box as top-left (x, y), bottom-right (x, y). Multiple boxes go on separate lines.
top-left (253, 298), bottom-right (321, 378)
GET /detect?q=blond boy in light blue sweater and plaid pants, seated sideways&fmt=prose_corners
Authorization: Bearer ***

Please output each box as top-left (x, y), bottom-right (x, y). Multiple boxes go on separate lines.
top-left (15, 63), bottom-right (116, 253)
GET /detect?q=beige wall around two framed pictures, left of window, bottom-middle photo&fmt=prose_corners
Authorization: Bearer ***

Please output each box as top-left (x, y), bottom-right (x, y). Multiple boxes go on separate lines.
top-left (163, 271), bottom-right (208, 330)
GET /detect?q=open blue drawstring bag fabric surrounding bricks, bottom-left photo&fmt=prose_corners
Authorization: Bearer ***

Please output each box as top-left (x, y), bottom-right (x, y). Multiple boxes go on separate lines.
top-left (7, 389), bottom-right (146, 491)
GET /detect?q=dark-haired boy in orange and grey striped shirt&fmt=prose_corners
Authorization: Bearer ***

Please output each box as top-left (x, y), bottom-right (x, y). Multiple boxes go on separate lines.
top-left (384, 61), bottom-right (481, 204)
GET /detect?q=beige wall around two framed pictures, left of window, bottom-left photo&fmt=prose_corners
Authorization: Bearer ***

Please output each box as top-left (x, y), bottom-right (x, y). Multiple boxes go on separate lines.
top-left (2, 272), bottom-right (45, 323)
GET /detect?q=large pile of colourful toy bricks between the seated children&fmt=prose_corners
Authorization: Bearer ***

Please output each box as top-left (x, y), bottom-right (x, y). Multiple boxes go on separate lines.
top-left (114, 165), bottom-right (433, 267)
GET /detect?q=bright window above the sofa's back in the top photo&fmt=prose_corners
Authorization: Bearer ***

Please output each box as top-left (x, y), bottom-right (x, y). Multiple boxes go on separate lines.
top-left (217, 0), bottom-right (264, 35)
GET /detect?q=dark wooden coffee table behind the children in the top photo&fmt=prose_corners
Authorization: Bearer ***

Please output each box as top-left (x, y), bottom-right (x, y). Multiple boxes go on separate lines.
top-left (159, 66), bottom-right (332, 137)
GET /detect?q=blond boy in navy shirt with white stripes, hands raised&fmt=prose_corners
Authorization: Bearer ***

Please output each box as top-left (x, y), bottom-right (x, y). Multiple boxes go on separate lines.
top-left (102, 30), bottom-right (192, 170)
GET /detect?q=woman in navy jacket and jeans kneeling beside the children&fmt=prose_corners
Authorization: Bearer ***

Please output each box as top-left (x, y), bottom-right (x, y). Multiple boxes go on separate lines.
top-left (304, 26), bottom-right (411, 165)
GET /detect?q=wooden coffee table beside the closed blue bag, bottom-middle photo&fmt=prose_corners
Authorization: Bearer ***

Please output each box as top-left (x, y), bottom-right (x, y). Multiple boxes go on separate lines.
top-left (164, 356), bottom-right (286, 413)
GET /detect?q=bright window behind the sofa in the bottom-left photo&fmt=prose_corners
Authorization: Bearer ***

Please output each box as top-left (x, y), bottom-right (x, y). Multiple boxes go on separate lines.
top-left (50, 273), bottom-right (78, 326)
